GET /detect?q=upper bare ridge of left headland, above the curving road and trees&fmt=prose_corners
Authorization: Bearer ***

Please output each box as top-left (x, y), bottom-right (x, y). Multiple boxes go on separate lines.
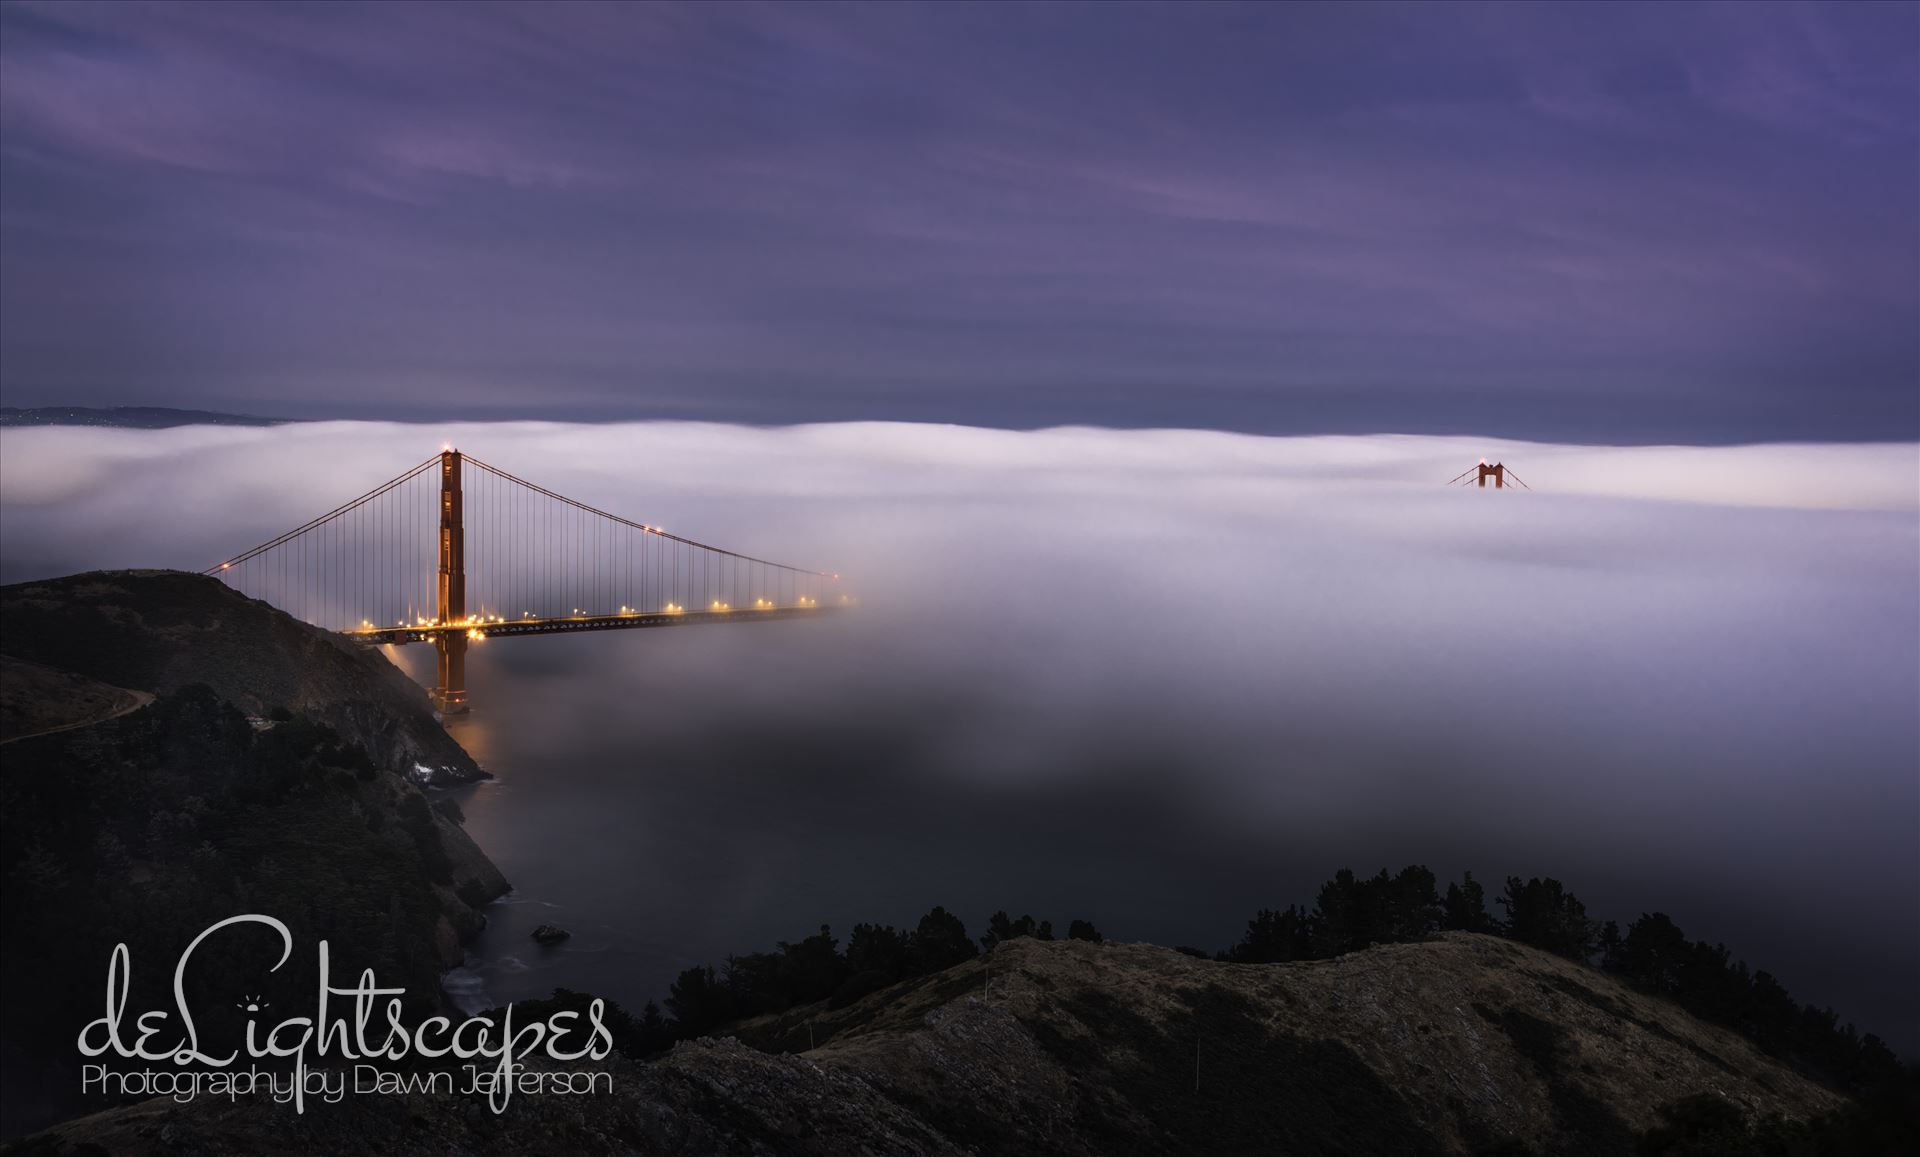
top-left (0, 570), bottom-right (486, 785)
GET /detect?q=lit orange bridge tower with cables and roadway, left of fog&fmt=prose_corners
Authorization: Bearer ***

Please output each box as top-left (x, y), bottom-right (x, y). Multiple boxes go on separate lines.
top-left (205, 447), bottom-right (851, 714)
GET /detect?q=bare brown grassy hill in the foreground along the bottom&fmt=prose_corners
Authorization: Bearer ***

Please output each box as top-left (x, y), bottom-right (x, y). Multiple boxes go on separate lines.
top-left (7, 934), bottom-right (1839, 1157)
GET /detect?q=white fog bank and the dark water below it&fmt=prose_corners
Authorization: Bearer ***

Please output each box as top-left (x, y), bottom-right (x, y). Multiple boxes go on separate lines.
top-left (0, 424), bottom-right (1920, 1048)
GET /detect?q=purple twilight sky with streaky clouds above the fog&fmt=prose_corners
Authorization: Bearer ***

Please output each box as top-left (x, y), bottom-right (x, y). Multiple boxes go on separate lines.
top-left (0, 2), bottom-right (1920, 443)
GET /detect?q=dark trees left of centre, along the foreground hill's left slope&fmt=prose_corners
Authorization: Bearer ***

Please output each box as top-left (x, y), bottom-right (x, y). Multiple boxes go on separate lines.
top-left (668, 908), bottom-right (1100, 1048)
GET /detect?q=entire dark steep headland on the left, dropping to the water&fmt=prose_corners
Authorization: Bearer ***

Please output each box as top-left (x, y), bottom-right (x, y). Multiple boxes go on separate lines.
top-left (0, 572), bottom-right (507, 1136)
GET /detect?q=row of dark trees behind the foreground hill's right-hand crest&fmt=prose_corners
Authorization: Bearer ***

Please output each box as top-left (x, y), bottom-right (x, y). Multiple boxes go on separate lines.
top-left (1215, 863), bottom-right (1899, 1088)
